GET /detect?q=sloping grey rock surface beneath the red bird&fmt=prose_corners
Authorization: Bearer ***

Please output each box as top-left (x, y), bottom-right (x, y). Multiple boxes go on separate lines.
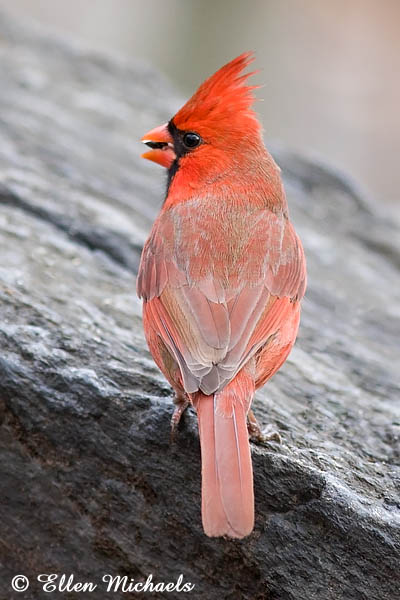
top-left (0, 10), bottom-right (400, 600)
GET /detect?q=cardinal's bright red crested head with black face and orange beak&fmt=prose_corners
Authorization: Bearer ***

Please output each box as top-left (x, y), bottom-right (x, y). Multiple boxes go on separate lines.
top-left (142, 52), bottom-right (264, 195)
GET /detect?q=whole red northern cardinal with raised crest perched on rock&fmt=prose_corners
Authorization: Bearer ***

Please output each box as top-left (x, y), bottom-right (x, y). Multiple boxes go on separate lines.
top-left (137, 53), bottom-right (306, 538)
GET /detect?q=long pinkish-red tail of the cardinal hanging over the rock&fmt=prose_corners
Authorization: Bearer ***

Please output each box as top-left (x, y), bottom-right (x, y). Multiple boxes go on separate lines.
top-left (193, 371), bottom-right (254, 538)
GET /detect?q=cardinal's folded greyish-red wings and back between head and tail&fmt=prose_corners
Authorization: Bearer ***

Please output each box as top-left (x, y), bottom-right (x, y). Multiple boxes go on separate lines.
top-left (137, 200), bottom-right (305, 394)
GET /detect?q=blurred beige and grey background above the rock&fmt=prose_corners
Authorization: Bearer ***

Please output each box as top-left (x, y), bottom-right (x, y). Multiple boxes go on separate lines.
top-left (0, 0), bottom-right (400, 210)
